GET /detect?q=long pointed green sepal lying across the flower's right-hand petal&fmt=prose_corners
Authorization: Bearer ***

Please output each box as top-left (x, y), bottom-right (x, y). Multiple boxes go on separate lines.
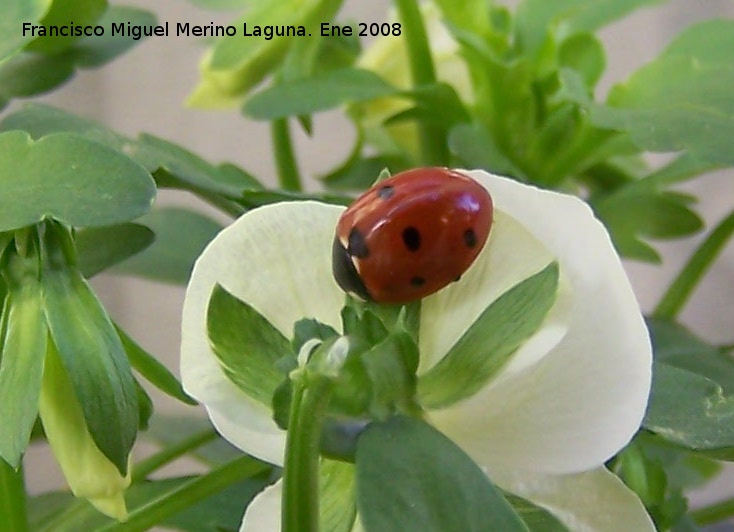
top-left (418, 262), bottom-right (559, 408)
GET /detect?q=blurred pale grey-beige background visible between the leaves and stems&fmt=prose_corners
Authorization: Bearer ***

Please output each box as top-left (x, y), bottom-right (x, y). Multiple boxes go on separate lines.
top-left (17, 0), bottom-right (734, 520)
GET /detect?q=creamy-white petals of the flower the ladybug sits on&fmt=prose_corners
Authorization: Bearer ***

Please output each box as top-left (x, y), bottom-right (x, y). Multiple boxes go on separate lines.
top-left (181, 171), bottom-right (654, 532)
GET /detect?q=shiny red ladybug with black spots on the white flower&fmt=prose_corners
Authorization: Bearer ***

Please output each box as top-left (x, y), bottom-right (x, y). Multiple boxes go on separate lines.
top-left (332, 168), bottom-right (493, 303)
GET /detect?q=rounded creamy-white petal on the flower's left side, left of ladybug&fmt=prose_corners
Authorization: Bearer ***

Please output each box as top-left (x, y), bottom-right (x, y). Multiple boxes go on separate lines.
top-left (181, 202), bottom-right (344, 464)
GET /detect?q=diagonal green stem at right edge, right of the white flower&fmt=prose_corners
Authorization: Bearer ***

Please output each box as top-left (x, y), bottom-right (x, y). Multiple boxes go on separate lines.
top-left (653, 211), bottom-right (734, 319)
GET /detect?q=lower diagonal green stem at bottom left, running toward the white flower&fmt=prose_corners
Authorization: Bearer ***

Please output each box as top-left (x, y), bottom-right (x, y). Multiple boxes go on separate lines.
top-left (97, 456), bottom-right (270, 532)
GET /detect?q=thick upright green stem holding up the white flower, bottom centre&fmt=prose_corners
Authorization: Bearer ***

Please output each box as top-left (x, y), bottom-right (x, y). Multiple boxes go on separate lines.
top-left (281, 372), bottom-right (334, 532)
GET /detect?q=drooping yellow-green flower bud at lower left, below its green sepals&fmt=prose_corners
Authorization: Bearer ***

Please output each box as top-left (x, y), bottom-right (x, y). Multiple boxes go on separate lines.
top-left (39, 341), bottom-right (130, 521)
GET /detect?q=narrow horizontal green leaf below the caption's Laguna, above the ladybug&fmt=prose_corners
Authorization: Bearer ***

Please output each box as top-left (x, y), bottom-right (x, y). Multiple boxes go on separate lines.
top-left (243, 68), bottom-right (400, 120)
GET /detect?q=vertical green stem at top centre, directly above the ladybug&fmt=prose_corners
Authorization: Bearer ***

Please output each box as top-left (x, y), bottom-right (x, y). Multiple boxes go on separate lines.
top-left (395, 0), bottom-right (449, 165)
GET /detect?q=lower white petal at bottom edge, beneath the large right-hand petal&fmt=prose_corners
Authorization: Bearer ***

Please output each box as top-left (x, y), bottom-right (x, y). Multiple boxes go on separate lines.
top-left (495, 467), bottom-right (655, 532)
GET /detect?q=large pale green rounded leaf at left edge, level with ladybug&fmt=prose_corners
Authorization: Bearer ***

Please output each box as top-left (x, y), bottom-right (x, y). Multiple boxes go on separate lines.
top-left (0, 131), bottom-right (156, 231)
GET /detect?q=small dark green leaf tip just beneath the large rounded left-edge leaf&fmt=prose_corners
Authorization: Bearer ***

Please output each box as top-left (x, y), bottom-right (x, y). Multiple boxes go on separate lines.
top-left (75, 223), bottom-right (155, 278)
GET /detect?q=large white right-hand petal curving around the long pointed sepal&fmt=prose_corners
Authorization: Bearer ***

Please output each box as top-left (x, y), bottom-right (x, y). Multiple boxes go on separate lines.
top-left (428, 171), bottom-right (651, 476)
